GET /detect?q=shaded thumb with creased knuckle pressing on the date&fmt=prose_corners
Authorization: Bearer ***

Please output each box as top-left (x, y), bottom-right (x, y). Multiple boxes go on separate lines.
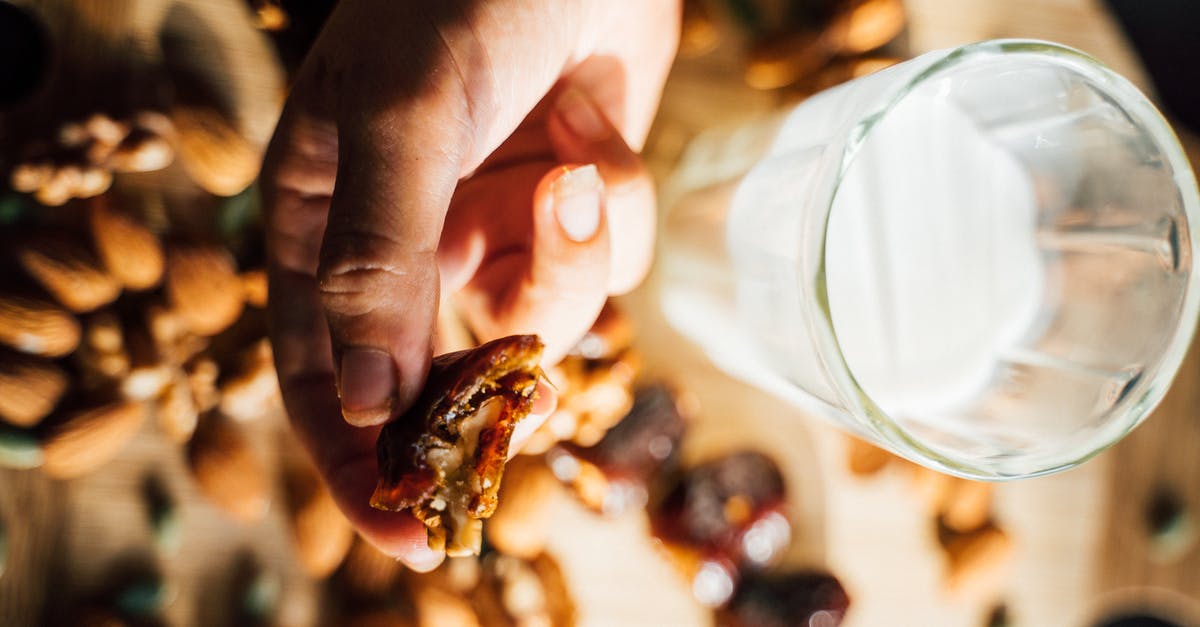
top-left (317, 114), bottom-right (461, 426)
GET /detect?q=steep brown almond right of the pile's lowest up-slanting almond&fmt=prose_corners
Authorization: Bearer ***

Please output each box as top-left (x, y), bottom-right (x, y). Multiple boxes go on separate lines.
top-left (187, 413), bottom-right (271, 523)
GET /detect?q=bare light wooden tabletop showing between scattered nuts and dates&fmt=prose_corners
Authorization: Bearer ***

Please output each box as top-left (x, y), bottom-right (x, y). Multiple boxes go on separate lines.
top-left (0, 0), bottom-right (1200, 627)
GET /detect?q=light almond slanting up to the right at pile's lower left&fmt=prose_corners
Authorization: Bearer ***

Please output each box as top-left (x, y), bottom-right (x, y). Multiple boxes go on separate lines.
top-left (42, 401), bottom-right (145, 479)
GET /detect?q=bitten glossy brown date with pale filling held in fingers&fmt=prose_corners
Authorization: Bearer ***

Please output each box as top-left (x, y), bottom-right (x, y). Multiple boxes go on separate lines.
top-left (371, 335), bottom-right (542, 556)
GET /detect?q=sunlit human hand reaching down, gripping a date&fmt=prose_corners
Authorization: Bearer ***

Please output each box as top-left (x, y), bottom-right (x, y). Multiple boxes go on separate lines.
top-left (262, 0), bottom-right (679, 569)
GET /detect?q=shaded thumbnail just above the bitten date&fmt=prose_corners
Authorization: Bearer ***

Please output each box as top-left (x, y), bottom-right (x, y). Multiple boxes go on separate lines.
top-left (338, 348), bottom-right (396, 425)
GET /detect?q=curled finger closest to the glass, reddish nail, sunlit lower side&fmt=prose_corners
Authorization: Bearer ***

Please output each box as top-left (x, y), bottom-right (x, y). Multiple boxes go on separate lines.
top-left (547, 86), bottom-right (656, 294)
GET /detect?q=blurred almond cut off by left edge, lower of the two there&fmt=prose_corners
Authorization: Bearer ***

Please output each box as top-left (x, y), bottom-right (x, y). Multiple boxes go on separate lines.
top-left (0, 352), bottom-right (70, 428)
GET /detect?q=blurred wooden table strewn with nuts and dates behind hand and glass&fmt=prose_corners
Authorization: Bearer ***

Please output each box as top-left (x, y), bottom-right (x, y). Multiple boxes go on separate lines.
top-left (0, 0), bottom-right (1200, 627)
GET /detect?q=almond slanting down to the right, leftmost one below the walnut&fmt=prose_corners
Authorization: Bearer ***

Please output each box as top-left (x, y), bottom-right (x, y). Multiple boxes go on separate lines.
top-left (17, 233), bottom-right (121, 312)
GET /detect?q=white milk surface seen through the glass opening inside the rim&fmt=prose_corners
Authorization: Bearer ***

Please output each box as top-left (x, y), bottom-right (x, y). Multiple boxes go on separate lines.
top-left (826, 94), bottom-right (1043, 418)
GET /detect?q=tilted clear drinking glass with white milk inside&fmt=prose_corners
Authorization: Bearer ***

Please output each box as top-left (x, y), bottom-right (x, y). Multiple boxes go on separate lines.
top-left (656, 40), bottom-right (1200, 479)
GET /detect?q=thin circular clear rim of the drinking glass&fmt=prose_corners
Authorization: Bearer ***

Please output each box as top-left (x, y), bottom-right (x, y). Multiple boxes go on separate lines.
top-left (804, 40), bottom-right (1200, 480)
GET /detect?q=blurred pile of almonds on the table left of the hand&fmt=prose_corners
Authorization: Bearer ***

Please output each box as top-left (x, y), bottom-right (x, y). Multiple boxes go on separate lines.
top-left (0, 196), bottom-right (280, 497)
